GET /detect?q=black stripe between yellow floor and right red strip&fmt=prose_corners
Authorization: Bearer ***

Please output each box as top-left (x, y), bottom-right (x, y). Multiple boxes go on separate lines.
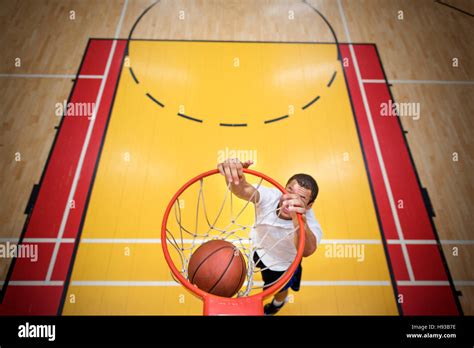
top-left (341, 44), bottom-right (403, 316)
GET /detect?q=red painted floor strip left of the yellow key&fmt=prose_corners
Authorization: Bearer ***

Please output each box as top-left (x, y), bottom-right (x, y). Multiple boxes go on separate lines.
top-left (0, 40), bottom-right (126, 315)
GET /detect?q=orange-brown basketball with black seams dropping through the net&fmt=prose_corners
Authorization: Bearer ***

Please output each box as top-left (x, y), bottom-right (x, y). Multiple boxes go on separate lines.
top-left (188, 240), bottom-right (247, 297)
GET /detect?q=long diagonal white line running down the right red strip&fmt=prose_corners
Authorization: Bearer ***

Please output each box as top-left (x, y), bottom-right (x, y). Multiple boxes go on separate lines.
top-left (337, 0), bottom-right (415, 280)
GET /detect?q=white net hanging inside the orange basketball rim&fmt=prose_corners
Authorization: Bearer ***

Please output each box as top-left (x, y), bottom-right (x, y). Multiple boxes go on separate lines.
top-left (166, 174), bottom-right (302, 297)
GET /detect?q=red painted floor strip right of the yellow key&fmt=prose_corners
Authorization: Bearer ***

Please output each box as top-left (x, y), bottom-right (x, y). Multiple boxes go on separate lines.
top-left (340, 44), bottom-right (460, 315)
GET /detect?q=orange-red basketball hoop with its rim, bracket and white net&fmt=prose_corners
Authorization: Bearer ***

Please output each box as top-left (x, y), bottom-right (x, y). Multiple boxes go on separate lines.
top-left (161, 169), bottom-right (305, 315)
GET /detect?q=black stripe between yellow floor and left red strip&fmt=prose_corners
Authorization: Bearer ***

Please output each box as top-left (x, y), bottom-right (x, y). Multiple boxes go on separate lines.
top-left (57, 40), bottom-right (127, 315)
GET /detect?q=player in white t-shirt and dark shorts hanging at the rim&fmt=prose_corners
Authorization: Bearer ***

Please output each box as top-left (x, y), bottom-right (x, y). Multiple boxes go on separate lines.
top-left (217, 159), bottom-right (322, 315)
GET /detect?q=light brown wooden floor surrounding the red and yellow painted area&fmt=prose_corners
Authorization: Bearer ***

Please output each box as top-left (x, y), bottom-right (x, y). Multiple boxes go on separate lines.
top-left (0, 0), bottom-right (474, 315)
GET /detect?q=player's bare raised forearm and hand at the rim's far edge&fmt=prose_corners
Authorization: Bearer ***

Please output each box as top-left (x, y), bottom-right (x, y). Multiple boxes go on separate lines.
top-left (217, 158), bottom-right (260, 203)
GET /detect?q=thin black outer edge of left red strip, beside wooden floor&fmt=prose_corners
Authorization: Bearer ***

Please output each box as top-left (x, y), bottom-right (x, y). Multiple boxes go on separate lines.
top-left (0, 38), bottom-right (91, 304)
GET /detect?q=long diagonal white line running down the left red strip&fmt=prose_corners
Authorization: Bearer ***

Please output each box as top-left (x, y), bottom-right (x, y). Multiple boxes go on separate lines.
top-left (46, 0), bottom-right (128, 281)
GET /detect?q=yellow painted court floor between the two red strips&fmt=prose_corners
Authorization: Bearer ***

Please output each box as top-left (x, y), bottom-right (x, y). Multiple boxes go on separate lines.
top-left (63, 40), bottom-right (398, 315)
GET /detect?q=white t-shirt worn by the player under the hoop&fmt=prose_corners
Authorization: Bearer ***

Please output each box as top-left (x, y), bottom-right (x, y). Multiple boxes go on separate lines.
top-left (250, 186), bottom-right (323, 272)
